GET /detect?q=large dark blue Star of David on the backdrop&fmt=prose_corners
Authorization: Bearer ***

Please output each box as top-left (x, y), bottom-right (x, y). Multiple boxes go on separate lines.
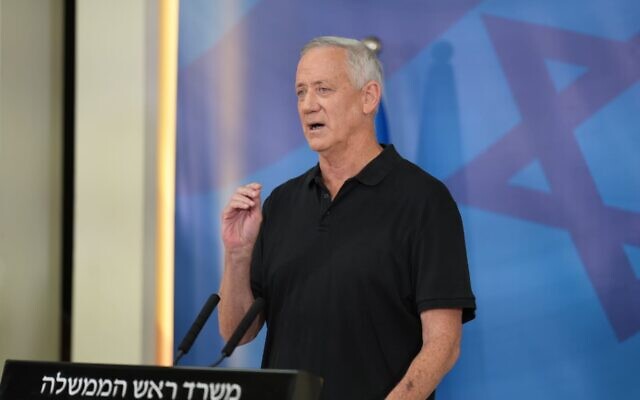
top-left (447, 16), bottom-right (640, 341)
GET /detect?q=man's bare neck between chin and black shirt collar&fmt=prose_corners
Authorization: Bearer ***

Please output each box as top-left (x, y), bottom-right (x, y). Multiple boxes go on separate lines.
top-left (318, 135), bottom-right (382, 199)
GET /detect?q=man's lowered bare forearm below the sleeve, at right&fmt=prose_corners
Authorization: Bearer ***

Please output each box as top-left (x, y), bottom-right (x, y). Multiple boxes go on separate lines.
top-left (387, 309), bottom-right (462, 400)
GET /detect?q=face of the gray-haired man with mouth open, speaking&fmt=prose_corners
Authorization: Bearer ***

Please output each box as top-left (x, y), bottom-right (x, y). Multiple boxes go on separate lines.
top-left (296, 47), bottom-right (366, 153)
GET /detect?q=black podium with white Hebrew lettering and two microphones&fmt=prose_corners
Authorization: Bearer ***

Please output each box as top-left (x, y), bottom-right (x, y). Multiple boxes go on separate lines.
top-left (0, 360), bottom-right (322, 400)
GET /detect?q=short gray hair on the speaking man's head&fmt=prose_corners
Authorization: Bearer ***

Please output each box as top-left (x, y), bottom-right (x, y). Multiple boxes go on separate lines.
top-left (300, 36), bottom-right (383, 93)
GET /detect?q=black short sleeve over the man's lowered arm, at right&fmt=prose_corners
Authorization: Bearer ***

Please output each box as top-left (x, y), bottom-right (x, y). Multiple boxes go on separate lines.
top-left (412, 184), bottom-right (476, 323)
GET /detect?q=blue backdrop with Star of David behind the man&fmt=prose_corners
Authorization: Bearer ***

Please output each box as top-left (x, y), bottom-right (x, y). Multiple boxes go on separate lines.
top-left (175, 0), bottom-right (640, 400)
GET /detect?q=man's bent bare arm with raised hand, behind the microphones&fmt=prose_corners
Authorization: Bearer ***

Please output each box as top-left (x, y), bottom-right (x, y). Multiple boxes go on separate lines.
top-left (218, 183), bottom-right (264, 344)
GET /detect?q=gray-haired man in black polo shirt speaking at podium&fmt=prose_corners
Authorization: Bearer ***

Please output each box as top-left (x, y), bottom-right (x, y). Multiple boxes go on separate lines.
top-left (220, 37), bottom-right (475, 400)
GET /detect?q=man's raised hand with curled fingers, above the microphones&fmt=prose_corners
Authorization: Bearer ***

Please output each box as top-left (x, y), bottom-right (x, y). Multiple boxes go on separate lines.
top-left (222, 183), bottom-right (262, 251)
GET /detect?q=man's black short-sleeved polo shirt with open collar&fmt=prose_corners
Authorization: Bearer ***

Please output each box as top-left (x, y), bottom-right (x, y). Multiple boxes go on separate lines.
top-left (251, 146), bottom-right (475, 400)
